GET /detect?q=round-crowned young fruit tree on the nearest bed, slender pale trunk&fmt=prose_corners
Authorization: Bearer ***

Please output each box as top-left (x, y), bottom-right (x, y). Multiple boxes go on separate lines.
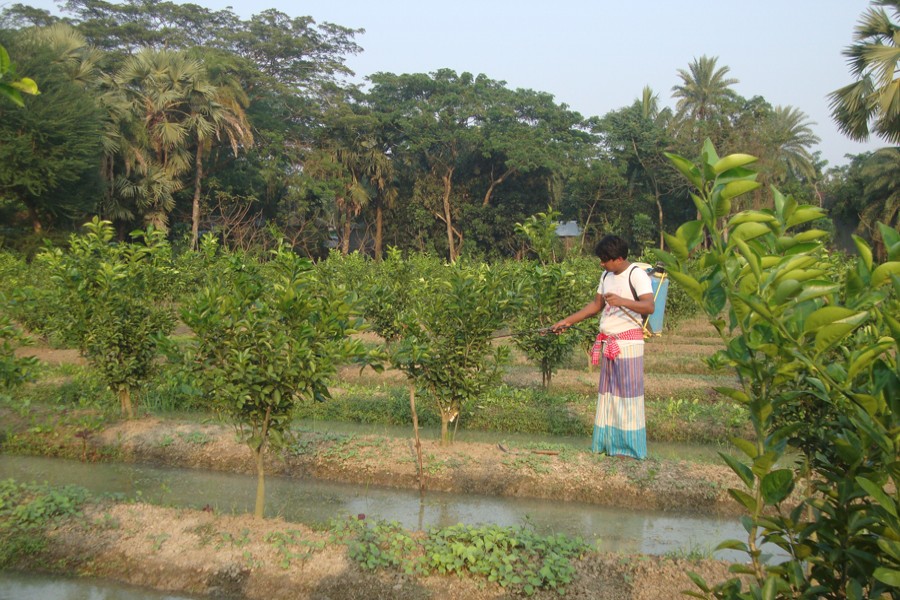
top-left (180, 247), bottom-right (367, 518)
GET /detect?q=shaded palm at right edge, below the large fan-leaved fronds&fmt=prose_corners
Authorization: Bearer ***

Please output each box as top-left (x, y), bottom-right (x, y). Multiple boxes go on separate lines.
top-left (858, 148), bottom-right (900, 260)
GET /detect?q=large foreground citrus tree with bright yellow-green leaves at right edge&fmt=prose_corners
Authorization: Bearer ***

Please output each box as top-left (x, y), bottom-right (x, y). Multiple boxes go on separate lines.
top-left (658, 141), bottom-right (900, 599)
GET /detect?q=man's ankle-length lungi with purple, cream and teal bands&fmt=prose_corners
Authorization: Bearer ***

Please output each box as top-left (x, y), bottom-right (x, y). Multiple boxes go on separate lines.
top-left (591, 340), bottom-right (647, 459)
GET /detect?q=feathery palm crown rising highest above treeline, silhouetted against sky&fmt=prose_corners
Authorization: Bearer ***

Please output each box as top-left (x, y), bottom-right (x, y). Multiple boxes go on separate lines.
top-left (672, 56), bottom-right (738, 123)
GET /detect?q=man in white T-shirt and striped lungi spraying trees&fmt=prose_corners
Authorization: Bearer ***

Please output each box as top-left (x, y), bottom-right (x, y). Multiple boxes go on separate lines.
top-left (552, 235), bottom-right (655, 459)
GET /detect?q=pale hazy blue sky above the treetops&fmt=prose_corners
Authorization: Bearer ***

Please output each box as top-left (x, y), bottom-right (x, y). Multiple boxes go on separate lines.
top-left (14, 0), bottom-right (885, 165)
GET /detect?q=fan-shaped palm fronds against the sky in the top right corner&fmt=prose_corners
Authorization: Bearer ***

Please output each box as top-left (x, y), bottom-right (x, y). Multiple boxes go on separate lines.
top-left (828, 0), bottom-right (900, 144)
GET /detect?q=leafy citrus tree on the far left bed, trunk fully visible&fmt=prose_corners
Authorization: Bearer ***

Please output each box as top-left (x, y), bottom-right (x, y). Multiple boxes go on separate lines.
top-left (38, 217), bottom-right (176, 418)
